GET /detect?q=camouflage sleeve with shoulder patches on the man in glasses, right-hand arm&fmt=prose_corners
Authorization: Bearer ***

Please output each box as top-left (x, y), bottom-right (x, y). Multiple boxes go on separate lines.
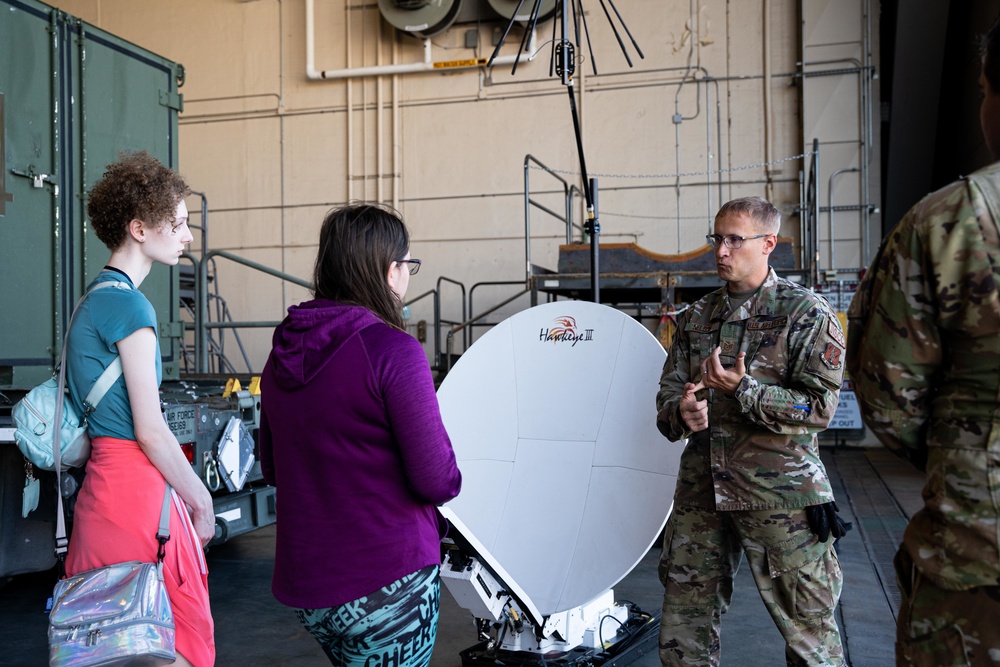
top-left (736, 302), bottom-right (845, 435)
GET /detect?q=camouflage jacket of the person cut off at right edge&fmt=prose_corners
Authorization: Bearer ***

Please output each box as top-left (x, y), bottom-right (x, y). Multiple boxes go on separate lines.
top-left (848, 163), bottom-right (1000, 590)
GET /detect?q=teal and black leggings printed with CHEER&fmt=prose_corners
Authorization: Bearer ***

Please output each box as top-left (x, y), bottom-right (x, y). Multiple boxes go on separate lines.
top-left (295, 565), bottom-right (441, 667)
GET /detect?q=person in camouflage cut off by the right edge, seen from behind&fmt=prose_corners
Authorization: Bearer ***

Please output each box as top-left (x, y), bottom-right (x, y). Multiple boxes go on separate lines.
top-left (847, 15), bottom-right (1000, 667)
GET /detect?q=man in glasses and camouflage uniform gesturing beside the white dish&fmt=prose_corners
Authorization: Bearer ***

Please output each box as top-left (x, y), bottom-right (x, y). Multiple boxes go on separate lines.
top-left (656, 197), bottom-right (844, 667)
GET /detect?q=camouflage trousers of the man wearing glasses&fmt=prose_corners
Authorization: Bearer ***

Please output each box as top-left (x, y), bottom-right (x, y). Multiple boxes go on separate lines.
top-left (659, 505), bottom-right (844, 667)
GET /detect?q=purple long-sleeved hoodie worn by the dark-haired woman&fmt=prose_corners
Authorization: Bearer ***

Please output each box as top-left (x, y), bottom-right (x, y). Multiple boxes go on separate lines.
top-left (260, 299), bottom-right (462, 609)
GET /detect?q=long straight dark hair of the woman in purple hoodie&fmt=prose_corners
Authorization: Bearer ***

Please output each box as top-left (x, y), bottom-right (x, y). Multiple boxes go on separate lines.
top-left (313, 204), bottom-right (410, 329)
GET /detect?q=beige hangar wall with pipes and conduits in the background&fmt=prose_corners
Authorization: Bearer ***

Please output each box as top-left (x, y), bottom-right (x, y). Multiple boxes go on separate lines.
top-left (39, 0), bottom-right (879, 370)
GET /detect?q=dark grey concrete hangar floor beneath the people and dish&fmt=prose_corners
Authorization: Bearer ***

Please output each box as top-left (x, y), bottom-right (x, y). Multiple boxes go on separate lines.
top-left (0, 448), bottom-right (922, 667)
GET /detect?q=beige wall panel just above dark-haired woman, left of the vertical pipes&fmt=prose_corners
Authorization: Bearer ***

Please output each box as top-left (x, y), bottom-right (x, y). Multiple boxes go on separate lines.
top-left (284, 113), bottom-right (347, 206)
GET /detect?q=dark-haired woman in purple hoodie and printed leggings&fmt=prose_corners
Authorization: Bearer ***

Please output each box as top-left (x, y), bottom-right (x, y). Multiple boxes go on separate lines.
top-left (260, 204), bottom-right (462, 667)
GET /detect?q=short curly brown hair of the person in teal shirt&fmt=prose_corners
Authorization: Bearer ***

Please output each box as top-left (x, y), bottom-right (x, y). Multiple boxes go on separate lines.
top-left (87, 151), bottom-right (191, 251)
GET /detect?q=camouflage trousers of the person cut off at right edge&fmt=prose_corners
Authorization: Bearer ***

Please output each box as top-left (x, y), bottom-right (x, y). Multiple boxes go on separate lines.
top-left (895, 549), bottom-right (1000, 667)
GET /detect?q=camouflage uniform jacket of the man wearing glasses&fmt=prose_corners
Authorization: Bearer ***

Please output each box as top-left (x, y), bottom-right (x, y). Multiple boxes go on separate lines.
top-left (656, 269), bottom-right (844, 510)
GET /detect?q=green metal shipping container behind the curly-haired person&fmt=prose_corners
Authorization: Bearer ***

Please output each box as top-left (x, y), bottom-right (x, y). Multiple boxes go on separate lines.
top-left (0, 0), bottom-right (184, 391)
